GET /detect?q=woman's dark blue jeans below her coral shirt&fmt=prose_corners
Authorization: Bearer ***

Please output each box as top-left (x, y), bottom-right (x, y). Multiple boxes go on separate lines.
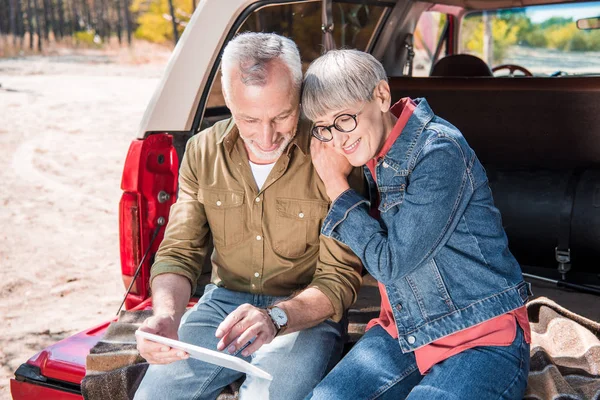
top-left (307, 325), bottom-right (529, 400)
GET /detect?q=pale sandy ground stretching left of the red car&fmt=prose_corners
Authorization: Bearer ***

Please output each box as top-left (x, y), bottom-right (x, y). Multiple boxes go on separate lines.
top-left (0, 43), bottom-right (169, 399)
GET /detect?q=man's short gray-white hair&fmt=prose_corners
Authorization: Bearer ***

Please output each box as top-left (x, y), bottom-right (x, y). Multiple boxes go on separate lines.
top-left (221, 32), bottom-right (302, 98)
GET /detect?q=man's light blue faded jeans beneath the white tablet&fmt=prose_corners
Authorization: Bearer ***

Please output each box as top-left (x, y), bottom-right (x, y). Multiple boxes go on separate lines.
top-left (135, 285), bottom-right (343, 400)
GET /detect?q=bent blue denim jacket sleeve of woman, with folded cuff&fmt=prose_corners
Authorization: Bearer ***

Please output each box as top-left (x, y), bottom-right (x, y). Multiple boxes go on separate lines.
top-left (322, 137), bottom-right (473, 284)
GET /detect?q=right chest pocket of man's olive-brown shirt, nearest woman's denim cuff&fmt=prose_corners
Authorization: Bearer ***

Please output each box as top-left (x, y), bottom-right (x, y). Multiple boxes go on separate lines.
top-left (272, 198), bottom-right (329, 258)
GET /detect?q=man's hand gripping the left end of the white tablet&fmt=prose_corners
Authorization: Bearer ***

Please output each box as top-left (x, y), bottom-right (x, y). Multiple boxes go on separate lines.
top-left (135, 314), bottom-right (189, 364)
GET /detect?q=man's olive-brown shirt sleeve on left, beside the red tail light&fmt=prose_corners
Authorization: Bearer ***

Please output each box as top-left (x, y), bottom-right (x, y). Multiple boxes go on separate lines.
top-left (150, 139), bottom-right (210, 293)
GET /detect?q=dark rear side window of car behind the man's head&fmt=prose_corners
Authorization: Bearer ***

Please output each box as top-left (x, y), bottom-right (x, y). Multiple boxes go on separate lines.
top-left (207, 2), bottom-right (389, 108)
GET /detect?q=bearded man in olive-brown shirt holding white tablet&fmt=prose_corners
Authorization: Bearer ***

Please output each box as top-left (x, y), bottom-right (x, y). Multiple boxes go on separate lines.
top-left (135, 33), bottom-right (361, 400)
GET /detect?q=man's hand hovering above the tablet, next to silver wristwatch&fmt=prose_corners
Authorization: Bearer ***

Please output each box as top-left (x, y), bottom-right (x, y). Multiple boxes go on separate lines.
top-left (215, 304), bottom-right (277, 357)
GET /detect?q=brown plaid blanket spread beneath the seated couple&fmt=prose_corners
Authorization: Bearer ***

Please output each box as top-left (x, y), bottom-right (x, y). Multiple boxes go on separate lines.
top-left (81, 297), bottom-right (600, 400)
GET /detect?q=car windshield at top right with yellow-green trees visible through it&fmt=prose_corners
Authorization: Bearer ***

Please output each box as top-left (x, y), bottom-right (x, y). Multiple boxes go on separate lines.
top-left (459, 2), bottom-right (600, 76)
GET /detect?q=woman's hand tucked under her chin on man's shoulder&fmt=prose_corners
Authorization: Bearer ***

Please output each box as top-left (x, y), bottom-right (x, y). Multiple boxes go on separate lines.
top-left (310, 138), bottom-right (352, 201)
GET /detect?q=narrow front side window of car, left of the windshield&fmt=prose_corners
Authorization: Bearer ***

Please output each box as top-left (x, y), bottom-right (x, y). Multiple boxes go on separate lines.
top-left (412, 11), bottom-right (447, 76)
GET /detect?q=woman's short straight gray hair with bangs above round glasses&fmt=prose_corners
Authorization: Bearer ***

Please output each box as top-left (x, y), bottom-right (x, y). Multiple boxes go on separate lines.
top-left (302, 49), bottom-right (387, 121)
